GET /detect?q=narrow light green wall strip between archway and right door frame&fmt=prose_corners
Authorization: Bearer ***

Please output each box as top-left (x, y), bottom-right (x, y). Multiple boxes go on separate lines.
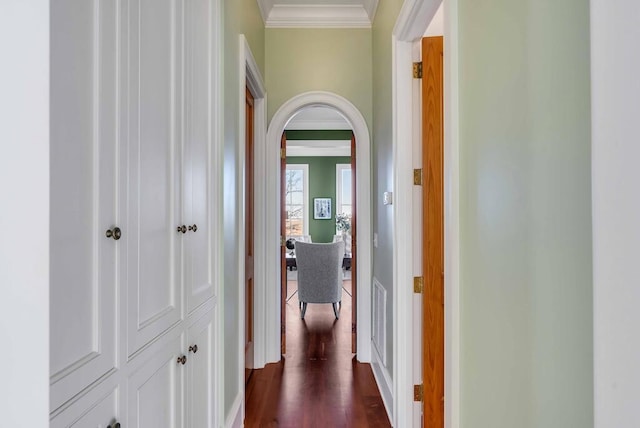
top-left (371, 0), bottom-right (400, 384)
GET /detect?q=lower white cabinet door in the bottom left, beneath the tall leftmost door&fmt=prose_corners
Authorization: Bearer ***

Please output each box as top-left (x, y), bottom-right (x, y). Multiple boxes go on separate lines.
top-left (50, 388), bottom-right (119, 428)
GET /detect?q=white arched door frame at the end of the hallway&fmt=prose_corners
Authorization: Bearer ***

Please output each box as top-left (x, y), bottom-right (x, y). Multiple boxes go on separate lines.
top-left (256, 91), bottom-right (372, 367)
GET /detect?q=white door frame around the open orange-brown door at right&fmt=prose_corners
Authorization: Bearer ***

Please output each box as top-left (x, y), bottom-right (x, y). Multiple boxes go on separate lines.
top-left (392, 0), bottom-right (460, 428)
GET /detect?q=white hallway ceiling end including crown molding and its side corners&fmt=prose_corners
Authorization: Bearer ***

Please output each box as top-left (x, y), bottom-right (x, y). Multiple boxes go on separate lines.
top-left (256, 0), bottom-right (378, 28)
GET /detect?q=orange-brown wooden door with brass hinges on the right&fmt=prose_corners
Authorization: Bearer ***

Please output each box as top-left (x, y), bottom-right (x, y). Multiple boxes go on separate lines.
top-left (422, 37), bottom-right (444, 428)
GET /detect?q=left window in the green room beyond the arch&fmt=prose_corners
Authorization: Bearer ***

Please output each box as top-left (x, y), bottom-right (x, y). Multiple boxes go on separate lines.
top-left (284, 164), bottom-right (309, 236)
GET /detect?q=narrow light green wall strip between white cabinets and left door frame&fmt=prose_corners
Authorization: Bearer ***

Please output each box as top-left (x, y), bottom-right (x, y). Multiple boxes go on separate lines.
top-left (219, 0), bottom-right (264, 418)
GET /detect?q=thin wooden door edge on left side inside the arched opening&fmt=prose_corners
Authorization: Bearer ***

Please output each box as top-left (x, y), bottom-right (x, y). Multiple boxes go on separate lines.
top-left (280, 132), bottom-right (287, 355)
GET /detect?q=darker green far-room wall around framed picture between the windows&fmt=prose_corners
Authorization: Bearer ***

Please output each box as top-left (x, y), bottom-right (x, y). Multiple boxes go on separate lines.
top-left (287, 156), bottom-right (351, 242)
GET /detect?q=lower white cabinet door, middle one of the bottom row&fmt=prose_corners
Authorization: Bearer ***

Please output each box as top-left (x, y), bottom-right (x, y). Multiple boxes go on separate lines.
top-left (126, 337), bottom-right (184, 428)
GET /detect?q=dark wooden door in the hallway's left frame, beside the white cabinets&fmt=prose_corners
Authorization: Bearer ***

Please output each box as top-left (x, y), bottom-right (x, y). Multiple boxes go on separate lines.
top-left (244, 88), bottom-right (254, 383)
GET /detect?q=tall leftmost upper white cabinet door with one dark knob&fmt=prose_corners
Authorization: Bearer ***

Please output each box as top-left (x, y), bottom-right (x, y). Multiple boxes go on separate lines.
top-left (50, 0), bottom-right (117, 410)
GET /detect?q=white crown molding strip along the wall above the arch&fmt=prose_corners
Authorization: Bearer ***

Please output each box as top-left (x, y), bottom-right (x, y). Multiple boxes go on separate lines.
top-left (265, 4), bottom-right (371, 28)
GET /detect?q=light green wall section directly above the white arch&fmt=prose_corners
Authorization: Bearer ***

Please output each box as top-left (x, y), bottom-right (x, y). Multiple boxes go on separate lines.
top-left (265, 28), bottom-right (372, 129)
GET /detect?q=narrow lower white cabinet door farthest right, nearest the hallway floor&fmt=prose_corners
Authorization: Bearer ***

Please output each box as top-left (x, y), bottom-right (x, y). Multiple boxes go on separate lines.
top-left (186, 311), bottom-right (215, 428)
